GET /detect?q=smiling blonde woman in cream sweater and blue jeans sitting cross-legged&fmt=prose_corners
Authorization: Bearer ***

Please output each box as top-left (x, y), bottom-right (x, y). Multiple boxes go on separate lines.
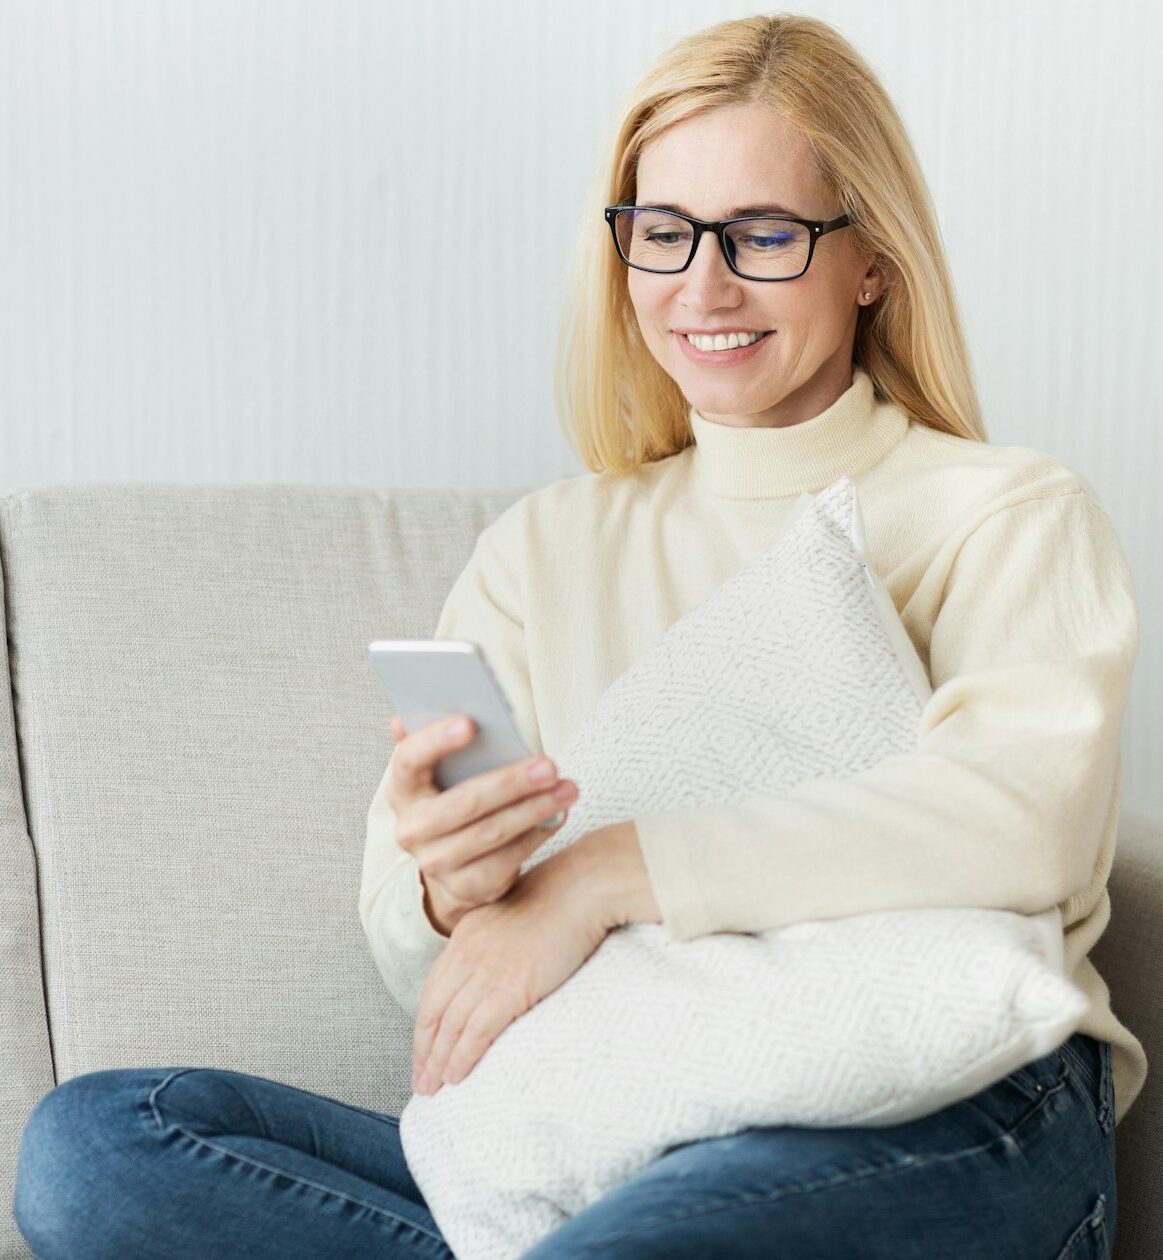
top-left (15, 16), bottom-right (1145, 1260)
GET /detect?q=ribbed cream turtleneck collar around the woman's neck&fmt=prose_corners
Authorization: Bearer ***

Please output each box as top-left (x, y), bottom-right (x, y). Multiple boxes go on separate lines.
top-left (690, 363), bottom-right (908, 499)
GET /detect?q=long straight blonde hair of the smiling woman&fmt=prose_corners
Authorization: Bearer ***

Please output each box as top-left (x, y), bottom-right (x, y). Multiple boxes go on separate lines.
top-left (554, 14), bottom-right (988, 474)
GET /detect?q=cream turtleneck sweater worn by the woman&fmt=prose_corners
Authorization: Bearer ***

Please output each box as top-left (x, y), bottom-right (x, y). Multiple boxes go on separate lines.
top-left (359, 367), bottom-right (1147, 1119)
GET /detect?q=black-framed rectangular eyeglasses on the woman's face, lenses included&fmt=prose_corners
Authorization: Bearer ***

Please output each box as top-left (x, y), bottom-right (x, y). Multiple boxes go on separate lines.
top-left (604, 205), bottom-right (852, 280)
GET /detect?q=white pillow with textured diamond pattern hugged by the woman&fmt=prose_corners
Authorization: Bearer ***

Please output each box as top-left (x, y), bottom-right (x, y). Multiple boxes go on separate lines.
top-left (399, 476), bottom-right (1087, 1260)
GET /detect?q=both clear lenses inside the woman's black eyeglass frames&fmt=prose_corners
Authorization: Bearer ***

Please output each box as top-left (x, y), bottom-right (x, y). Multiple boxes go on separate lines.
top-left (614, 207), bottom-right (811, 280)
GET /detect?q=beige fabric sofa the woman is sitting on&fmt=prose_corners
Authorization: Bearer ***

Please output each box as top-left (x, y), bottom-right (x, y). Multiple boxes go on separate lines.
top-left (0, 483), bottom-right (1163, 1260)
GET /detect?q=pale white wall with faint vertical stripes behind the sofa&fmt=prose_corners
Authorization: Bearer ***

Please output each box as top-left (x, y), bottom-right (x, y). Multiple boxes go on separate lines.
top-left (0, 0), bottom-right (1163, 813)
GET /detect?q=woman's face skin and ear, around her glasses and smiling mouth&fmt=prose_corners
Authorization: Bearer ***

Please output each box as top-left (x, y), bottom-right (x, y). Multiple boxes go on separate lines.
top-left (626, 103), bottom-right (882, 427)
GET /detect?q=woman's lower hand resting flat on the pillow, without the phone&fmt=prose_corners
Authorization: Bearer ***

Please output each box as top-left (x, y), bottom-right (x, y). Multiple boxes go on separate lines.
top-left (412, 837), bottom-right (609, 1094)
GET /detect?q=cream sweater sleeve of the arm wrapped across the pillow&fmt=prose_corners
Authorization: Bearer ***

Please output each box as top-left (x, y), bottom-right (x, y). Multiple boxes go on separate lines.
top-left (634, 489), bottom-right (1139, 940)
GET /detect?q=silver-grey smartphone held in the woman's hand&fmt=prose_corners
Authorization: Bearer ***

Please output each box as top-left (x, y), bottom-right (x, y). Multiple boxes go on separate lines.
top-left (368, 639), bottom-right (566, 828)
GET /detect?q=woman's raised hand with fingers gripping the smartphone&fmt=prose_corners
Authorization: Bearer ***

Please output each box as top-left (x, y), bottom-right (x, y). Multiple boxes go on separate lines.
top-left (384, 716), bottom-right (577, 936)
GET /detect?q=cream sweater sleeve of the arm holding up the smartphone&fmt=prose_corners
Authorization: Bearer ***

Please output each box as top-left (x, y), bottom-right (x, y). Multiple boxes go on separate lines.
top-left (359, 506), bottom-right (541, 1017)
